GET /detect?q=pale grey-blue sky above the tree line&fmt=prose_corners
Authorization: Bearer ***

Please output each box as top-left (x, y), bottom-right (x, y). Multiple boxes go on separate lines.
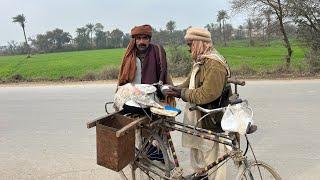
top-left (0, 0), bottom-right (246, 46)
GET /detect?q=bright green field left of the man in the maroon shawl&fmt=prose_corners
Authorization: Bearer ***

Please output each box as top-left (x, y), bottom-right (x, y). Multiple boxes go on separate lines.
top-left (0, 49), bottom-right (124, 80)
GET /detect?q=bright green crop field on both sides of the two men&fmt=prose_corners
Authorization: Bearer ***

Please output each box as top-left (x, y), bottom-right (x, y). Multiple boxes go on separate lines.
top-left (0, 41), bottom-right (305, 81)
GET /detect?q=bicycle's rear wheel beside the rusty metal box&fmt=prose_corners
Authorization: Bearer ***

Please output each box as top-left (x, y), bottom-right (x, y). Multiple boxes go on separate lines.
top-left (134, 131), bottom-right (174, 179)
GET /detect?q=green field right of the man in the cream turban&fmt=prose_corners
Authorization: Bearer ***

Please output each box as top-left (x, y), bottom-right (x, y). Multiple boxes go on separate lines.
top-left (217, 39), bottom-right (306, 71)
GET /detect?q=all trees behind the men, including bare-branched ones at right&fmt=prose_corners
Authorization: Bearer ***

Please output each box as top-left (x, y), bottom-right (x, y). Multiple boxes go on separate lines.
top-left (0, 0), bottom-right (320, 71)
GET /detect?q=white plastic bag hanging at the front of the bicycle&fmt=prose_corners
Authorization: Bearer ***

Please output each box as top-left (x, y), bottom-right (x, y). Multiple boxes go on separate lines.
top-left (221, 102), bottom-right (253, 135)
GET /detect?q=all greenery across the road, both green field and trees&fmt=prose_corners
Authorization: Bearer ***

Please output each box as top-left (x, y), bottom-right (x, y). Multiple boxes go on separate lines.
top-left (0, 0), bottom-right (320, 82)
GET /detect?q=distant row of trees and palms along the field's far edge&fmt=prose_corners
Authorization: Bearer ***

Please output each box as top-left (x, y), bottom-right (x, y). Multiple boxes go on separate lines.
top-left (1, 17), bottom-right (296, 55)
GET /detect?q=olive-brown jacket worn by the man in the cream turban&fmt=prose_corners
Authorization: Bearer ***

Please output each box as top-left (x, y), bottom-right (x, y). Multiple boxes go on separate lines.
top-left (180, 54), bottom-right (229, 134)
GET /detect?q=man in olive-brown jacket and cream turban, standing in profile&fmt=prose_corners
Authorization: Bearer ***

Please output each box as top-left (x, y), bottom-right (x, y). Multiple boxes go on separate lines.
top-left (167, 28), bottom-right (230, 180)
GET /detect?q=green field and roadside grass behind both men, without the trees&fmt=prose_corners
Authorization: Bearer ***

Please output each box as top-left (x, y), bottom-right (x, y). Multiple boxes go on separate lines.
top-left (0, 40), bottom-right (308, 82)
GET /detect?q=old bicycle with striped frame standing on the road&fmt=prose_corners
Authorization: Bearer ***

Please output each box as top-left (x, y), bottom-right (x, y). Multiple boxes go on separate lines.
top-left (104, 80), bottom-right (281, 180)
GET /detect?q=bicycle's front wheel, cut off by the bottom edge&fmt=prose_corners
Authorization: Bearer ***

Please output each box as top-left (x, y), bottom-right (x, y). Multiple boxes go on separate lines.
top-left (237, 161), bottom-right (281, 180)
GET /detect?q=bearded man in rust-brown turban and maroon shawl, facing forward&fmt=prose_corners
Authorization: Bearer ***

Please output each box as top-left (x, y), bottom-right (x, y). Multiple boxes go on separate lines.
top-left (118, 25), bottom-right (172, 86)
